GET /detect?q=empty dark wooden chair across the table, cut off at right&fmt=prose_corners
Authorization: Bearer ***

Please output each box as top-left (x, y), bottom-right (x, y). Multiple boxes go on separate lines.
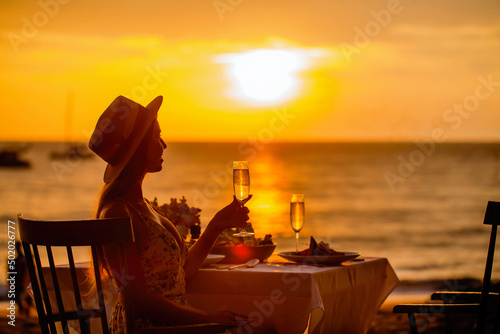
top-left (393, 201), bottom-right (500, 334)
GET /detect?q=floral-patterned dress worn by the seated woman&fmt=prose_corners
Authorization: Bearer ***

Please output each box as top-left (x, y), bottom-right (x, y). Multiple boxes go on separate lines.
top-left (109, 203), bottom-right (188, 334)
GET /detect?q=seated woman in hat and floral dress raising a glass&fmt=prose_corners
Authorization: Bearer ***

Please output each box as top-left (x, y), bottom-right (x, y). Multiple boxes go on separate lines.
top-left (89, 96), bottom-right (274, 333)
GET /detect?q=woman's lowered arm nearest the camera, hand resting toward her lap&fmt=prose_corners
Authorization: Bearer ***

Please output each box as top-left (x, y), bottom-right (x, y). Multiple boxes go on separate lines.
top-left (101, 203), bottom-right (244, 326)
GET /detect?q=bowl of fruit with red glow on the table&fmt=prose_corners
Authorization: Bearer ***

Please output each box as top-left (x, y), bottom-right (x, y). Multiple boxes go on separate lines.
top-left (210, 229), bottom-right (276, 264)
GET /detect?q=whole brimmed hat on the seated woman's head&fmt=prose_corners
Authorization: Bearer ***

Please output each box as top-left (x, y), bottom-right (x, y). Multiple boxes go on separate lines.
top-left (89, 96), bottom-right (163, 183)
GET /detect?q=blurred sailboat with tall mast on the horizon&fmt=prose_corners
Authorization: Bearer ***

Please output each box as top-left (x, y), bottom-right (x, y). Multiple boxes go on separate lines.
top-left (50, 91), bottom-right (95, 160)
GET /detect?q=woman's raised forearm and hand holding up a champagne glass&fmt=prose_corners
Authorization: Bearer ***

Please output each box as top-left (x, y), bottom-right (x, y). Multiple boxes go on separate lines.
top-left (184, 196), bottom-right (251, 279)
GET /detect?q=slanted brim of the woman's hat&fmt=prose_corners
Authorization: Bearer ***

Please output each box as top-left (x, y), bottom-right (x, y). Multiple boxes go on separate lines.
top-left (104, 95), bottom-right (163, 183)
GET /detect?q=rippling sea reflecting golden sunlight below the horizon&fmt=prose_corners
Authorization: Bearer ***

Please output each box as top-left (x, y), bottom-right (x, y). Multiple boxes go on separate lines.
top-left (0, 141), bottom-right (500, 282)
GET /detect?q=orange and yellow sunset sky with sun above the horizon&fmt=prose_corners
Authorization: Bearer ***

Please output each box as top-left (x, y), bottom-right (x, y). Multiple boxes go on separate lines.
top-left (0, 0), bottom-right (500, 141)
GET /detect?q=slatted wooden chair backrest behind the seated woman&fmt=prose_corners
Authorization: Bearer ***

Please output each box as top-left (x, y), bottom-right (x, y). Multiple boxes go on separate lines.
top-left (18, 215), bottom-right (134, 333)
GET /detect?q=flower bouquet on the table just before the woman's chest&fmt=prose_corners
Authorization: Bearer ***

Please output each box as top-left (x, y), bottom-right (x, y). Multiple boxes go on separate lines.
top-left (151, 196), bottom-right (201, 239)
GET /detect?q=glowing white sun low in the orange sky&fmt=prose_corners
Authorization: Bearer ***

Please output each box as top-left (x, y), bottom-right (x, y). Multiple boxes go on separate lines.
top-left (223, 49), bottom-right (304, 104)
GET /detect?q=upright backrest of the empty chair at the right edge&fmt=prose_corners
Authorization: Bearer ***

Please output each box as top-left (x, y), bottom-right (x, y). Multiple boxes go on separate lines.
top-left (476, 201), bottom-right (500, 333)
